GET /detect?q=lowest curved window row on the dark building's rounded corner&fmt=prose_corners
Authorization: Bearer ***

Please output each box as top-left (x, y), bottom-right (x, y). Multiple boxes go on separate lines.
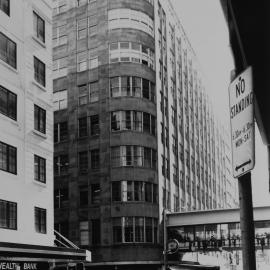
top-left (112, 217), bottom-right (158, 243)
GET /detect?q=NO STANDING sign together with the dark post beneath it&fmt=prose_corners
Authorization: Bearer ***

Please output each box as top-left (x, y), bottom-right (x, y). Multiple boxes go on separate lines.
top-left (229, 67), bottom-right (256, 270)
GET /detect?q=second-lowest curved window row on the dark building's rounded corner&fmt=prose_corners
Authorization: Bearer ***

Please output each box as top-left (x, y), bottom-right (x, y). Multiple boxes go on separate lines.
top-left (112, 181), bottom-right (158, 203)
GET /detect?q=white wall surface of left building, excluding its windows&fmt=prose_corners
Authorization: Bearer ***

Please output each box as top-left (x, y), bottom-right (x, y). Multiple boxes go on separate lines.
top-left (0, 0), bottom-right (54, 246)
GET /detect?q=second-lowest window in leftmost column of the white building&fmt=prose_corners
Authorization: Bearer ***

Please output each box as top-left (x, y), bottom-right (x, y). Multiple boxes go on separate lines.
top-left (0, 142), bottom-right (17, 174)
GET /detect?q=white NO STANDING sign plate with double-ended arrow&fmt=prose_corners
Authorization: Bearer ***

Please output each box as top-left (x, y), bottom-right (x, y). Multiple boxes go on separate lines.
top-left (229, 67), bottom-right (255, 178)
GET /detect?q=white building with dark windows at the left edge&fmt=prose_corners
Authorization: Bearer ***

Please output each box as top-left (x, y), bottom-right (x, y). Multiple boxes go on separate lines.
top-left (0, 0), bottom-right (54, 245)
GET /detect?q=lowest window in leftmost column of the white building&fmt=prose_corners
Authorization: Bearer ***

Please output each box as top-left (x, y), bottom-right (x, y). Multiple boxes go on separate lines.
top-left (0, 200), bottom-right (17, 230)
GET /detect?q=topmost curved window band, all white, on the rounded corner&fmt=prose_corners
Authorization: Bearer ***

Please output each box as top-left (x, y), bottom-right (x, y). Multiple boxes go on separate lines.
top-left (108, 8), bottom-right (154, 37)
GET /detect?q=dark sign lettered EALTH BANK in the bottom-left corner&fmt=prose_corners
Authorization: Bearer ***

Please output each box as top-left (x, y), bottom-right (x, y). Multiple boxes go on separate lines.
top-left (0, 260), bottom-right (49, 270)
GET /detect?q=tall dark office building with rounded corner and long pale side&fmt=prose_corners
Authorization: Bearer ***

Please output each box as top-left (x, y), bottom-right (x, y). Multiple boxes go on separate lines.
top-left (53, 0), bottom-right (238, 268)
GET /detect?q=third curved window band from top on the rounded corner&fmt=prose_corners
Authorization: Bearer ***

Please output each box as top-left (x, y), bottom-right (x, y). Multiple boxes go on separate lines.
top-left (110, 76), bottom-right (156, 102)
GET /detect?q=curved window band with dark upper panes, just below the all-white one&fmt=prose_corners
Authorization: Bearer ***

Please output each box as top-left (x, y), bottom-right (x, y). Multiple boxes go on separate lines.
top-left (110, 41), bottom-right (155, 70)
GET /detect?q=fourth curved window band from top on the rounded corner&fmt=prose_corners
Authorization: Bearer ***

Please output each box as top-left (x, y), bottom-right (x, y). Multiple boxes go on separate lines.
top-left (111, 111), bottom-right (156, 136)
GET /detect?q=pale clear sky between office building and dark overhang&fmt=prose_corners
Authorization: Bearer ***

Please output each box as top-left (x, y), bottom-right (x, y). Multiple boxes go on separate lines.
top-left (171, 0), bottom-right (270, 206)
